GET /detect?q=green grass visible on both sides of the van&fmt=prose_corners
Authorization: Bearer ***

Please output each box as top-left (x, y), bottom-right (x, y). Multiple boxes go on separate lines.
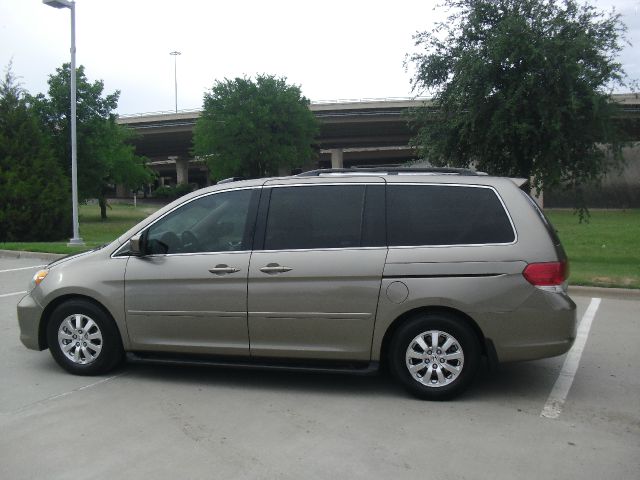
top-left (0, 204), bottom-right (640, 288)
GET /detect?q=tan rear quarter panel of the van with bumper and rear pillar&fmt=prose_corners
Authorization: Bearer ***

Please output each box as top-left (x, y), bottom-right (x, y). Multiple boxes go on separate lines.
top-left (372, 177), bottom-right (576, 361)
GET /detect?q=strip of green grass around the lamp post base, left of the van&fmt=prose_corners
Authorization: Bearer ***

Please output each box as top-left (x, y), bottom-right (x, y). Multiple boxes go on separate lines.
top-left (0, 203), bottom-right (158, 254)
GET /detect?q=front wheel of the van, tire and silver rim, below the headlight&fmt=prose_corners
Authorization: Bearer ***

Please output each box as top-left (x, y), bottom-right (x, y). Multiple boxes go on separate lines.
top-left (47, 300), bottom-right (124, 375)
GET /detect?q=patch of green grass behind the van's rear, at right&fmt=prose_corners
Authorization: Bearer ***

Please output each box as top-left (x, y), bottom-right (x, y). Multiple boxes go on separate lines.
top-left (545, 210), bottom-right (640, 288)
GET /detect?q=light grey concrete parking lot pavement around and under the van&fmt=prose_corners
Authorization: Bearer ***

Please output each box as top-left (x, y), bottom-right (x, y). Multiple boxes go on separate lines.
top-left (0, 253), bottom-right (640, 479)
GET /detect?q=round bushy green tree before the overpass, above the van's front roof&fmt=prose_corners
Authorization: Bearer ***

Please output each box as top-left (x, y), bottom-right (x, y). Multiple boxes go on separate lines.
top-left (194, 75), bottom-right (318, 180)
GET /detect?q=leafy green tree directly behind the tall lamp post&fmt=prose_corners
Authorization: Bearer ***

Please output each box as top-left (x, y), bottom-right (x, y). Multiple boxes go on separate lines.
top-left (33, 63), bottom-right (152, 220)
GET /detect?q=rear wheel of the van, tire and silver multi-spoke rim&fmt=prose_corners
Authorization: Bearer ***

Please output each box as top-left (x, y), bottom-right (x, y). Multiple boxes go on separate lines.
top-left (389, 313), bottom-right (480, 400)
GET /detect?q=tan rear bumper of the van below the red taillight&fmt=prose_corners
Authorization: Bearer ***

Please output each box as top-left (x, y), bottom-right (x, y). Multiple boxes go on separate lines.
top-left (478, 291), bottom-right (577, 362)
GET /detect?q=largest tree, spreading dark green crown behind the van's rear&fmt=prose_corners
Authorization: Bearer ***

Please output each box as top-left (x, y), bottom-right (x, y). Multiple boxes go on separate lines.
top-left (409, 0), bottom-right (625, 208)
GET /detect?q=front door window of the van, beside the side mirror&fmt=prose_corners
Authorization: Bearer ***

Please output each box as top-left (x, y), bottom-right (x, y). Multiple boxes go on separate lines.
top-left (145, 190), bottom-right (254, 255)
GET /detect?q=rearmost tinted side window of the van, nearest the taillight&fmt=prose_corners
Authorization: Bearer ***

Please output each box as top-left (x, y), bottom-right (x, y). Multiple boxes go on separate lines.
top-left (387, 185), bottom-right (515, 246)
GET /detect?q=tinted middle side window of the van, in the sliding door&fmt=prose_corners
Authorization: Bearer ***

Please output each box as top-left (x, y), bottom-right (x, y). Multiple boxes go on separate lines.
top-left (264, 185), bottom-right (384, 250)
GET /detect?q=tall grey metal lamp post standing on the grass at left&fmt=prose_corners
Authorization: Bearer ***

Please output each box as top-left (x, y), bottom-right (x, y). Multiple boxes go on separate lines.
top-left (42, 0), bottom-right (84, 246)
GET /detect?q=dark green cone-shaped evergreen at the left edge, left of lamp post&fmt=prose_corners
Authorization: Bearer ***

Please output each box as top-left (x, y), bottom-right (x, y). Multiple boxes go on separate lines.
top-left (0, 65), bottom-right (71, 242)
